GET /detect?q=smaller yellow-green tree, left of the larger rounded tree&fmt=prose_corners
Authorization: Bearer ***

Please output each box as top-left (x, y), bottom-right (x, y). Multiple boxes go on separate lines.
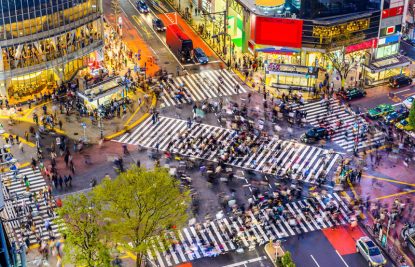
top-left (57, 194), bottom-right (111, 267)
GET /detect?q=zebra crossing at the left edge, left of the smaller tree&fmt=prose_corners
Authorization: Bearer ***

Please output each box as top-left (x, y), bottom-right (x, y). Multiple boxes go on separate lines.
top-left (1, 168), bottom-right (59, 244)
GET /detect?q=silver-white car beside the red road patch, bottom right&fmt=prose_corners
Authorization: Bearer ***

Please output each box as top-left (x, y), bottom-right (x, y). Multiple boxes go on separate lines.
top-left (356, 236), bottom-right (387, 266)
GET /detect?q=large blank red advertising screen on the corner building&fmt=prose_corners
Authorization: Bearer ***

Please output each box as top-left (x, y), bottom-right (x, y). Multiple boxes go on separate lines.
top-left (253, 17), bottom-right (303, 48)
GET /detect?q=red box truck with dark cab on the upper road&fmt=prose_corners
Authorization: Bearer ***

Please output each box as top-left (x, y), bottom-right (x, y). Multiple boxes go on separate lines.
top-left (166, 24), bottom-right (193, 63)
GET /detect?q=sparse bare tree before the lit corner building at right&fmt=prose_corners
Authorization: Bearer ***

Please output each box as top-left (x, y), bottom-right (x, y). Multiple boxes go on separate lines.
top-left (325, 47), bottom-right (358, 87)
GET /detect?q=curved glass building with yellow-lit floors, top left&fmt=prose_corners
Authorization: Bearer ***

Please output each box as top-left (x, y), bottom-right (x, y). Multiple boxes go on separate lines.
top-left (0, 0), bottom-right (104, 104)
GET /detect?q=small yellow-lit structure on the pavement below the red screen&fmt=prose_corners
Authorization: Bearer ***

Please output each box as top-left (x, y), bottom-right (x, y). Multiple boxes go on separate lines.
top-left (265, 63), bottom-right (318, 91)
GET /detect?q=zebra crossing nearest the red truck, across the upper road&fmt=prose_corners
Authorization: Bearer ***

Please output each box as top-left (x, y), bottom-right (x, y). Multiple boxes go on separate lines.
top-left (160, 70), bottom-right (246, 107)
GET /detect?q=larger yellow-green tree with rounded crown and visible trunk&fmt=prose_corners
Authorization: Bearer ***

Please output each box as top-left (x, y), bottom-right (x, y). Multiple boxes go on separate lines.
top-left (93, 167), bottom-right (190, 266)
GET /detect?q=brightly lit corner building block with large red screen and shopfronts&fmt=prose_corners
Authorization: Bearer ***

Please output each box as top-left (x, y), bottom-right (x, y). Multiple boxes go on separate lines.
top-left (197, 0), bottom-right (410, 90)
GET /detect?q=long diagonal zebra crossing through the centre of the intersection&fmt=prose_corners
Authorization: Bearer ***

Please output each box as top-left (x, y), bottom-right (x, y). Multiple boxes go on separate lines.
top-left (117, 116), bottom-right (341, 183)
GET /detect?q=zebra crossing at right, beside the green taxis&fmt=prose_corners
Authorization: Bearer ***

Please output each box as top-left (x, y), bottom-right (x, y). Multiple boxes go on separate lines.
top-left (298, 99), bottom-right (384, 152)
